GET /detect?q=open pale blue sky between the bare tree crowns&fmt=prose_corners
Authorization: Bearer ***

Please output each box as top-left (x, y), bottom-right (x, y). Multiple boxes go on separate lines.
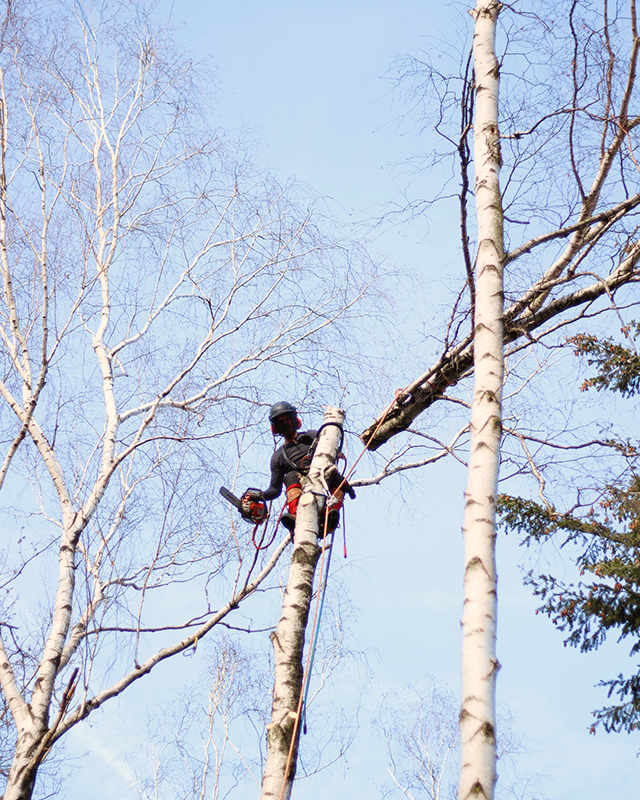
top-left (60, 0), bottom-right (640, 800)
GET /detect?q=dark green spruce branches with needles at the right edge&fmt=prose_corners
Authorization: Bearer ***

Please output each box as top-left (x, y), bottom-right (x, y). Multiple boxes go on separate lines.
top-left (498, 322), bottom-right (640, 733)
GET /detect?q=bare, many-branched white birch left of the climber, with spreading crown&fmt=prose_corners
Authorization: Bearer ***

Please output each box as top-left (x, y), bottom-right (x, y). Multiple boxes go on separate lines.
top-left (0, 3), bottom-right (366, 800)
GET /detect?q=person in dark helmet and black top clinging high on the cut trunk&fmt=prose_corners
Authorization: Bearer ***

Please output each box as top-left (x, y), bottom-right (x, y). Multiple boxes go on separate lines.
top-left (243, 400), bottom-right (356, 533)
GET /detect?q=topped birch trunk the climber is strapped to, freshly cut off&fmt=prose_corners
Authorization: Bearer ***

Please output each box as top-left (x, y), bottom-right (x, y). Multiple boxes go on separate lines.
top-left (260, 407), bottom-right (344, 800)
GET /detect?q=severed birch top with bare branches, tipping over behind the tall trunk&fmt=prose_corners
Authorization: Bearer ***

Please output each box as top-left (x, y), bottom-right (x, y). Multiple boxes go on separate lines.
top-left (362, 2), bottom-right (640, 450)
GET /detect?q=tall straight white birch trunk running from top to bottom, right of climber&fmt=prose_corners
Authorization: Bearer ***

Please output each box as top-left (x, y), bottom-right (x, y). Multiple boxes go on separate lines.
top-left (458, 0), bottom-right (504, 800)
